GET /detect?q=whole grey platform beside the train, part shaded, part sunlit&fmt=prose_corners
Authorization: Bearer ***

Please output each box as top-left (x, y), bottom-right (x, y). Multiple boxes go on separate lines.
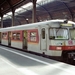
top-left (0, 46), bottom-right (75, 75)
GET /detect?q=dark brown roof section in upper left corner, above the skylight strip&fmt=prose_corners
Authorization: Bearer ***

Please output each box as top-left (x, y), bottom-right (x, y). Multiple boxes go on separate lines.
top-left (0, 0), bottom-right (31, 14)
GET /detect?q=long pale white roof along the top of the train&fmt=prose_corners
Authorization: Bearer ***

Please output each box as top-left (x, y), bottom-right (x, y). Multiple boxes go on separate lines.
top-left (0, 19), bottom-right (75, 32)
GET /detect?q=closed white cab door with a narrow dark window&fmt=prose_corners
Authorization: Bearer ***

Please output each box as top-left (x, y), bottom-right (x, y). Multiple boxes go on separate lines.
top-left (41, 27), bottom-right (47, 50)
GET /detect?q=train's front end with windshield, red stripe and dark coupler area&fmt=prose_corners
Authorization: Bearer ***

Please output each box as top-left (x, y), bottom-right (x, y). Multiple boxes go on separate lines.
top-left (49, 20), bottom-right (75, 60)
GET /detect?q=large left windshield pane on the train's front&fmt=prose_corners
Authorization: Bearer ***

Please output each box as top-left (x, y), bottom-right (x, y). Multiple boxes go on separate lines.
top-left (49, 28), bottom-right (68, 39)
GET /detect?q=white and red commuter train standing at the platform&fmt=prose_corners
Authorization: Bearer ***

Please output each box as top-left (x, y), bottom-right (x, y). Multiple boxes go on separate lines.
top-left (0, 19), bottom-right (75, 60)
